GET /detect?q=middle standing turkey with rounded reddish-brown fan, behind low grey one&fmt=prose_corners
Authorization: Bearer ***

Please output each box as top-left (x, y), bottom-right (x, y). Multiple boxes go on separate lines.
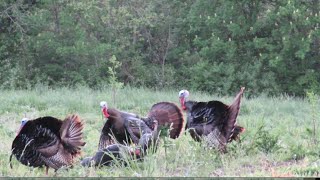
top-left (99, 101), bottom-right (184, 150)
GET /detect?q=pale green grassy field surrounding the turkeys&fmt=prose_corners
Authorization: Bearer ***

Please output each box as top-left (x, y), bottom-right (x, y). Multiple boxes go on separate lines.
top-left (0, 86), bottom-right (320, 177)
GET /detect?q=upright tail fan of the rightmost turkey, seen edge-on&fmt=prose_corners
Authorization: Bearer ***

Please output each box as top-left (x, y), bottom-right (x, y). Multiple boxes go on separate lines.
top-left (224, 87), bottom-right (245, 141)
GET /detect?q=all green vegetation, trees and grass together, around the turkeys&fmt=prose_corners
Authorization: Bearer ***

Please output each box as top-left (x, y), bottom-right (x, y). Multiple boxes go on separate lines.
top-left (0, 0), bottom-right (320, 177)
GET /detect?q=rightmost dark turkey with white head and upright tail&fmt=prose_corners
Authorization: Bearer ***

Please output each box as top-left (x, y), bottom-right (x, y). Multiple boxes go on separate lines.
top-left (179, 87), bottom-right (245, 151)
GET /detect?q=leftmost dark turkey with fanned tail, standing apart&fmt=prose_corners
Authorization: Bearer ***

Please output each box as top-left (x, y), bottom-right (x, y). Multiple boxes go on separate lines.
top-left (10, 115), bottom-right (85, 174)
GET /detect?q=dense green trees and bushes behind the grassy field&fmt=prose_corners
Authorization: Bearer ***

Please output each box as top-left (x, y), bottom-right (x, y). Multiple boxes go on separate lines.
top-left (0, 0), bottom-right (320, 96)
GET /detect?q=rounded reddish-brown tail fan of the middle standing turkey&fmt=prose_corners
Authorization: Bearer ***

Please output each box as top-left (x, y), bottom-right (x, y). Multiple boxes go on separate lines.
top-left (148, 102), bottom-right (184, 139)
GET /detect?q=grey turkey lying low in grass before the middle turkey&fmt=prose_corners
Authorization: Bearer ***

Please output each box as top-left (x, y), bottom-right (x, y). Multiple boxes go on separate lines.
top-left (81, 120), bottom-right (160, 167)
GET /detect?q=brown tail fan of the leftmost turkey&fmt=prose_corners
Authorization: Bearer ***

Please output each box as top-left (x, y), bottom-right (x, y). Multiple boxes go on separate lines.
top-left (60, 115), bottom-right (86, 155)
